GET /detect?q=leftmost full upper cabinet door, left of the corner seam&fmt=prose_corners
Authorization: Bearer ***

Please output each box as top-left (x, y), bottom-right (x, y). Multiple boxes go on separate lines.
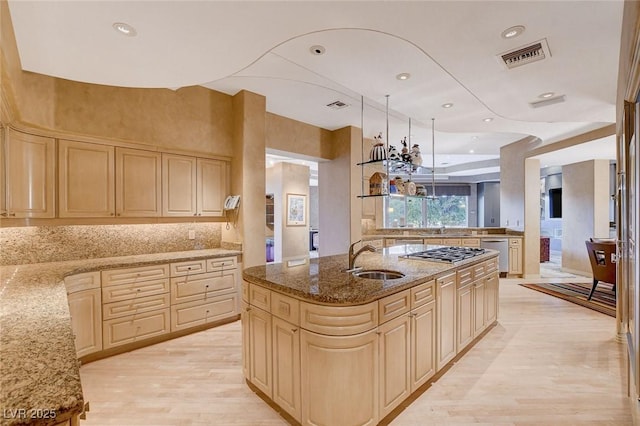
top-left (5, 130), bottom-right (56, 217)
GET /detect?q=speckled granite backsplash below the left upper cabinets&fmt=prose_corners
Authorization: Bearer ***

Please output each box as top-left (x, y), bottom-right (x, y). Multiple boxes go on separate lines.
top-left (0, 222), bottom-right (222, 265)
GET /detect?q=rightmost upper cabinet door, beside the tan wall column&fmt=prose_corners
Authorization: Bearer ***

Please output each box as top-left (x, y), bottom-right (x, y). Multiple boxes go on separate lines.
top-left (196, 158), bottom-right (227, 216)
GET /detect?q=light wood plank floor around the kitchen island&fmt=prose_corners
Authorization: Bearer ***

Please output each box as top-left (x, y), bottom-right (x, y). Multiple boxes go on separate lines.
top-left (80, 280), bottom-right (632, 426)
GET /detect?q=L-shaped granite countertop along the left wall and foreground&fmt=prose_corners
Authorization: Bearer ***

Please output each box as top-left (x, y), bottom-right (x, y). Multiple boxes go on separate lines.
top-left (0, 249), bottom-right (241, 425)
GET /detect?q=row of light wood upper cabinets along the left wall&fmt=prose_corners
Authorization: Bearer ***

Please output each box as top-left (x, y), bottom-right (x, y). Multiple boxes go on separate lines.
top-left (0, 128), bottom-right (230, 219)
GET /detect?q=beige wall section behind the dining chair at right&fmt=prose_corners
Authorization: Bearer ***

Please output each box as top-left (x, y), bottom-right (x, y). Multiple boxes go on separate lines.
top-left (562, 160), bottom-right (609, 275)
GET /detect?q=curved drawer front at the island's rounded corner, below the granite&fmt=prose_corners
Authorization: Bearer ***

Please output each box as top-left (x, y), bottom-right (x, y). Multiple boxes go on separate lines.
top-left (300, 301), bottom-right (378, 336)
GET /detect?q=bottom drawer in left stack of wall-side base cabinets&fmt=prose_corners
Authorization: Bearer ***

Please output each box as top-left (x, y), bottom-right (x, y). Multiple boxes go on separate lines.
top-left (102, 308), bottom-right (170, 349)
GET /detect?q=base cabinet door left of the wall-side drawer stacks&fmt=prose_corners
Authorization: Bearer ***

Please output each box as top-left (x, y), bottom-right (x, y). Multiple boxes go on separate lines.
top-left (68, 288), bottom-right (102, 358)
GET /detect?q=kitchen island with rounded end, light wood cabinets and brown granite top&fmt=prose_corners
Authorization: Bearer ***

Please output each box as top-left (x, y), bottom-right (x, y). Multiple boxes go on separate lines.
top-left (241, 244), bottom-right (498, 425)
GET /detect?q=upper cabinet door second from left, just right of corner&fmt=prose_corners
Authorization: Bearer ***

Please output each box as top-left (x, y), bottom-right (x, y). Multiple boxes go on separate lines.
top-left (58, 140), bottom-right (115, 217)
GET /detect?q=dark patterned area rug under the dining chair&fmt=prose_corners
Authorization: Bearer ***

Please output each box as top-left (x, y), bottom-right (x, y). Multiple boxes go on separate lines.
top-left (520, 283), bottom-right (616, 317)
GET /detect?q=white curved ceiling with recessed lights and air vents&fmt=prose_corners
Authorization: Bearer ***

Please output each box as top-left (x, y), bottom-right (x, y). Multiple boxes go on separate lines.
top-left (9, 0), bottom-right (623, 174)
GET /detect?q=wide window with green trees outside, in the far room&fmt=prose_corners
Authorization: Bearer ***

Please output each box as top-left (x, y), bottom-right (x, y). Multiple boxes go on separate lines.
top-left (384, 185), bottom-right (471, 228)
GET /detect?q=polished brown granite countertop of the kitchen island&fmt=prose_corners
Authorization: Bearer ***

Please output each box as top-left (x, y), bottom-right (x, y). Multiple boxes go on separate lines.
top-left (243, 244), bottom-right (498, 306)
